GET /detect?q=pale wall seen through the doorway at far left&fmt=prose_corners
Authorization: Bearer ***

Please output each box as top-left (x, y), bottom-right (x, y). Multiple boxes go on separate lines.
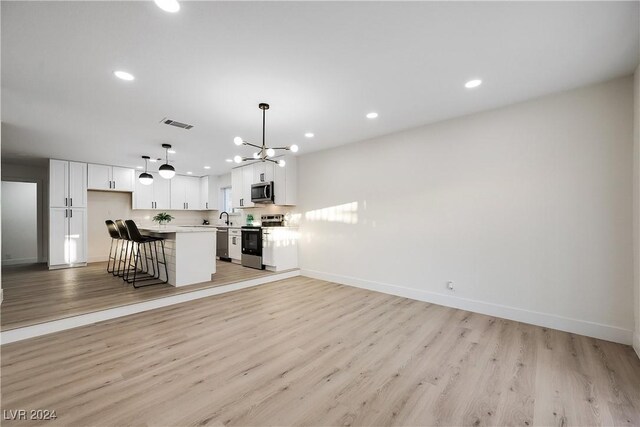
top-left (2, 181), bottom-right (38, 265)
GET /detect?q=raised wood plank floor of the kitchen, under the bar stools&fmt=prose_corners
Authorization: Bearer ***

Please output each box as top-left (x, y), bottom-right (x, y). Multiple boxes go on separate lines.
top-left (0, 261), bottom-right (292, 331)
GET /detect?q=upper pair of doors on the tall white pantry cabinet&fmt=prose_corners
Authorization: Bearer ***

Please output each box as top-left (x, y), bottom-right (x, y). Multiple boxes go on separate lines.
top-left (49, 159), bottom-right (87, 208)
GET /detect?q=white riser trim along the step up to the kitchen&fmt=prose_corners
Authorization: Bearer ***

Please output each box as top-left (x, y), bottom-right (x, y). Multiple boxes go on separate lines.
top-left (0, 270), bottom-right (300, 345)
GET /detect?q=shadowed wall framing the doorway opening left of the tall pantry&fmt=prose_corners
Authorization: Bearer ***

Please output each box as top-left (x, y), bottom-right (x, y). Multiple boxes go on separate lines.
top-left (2, 161), bottom-right (49, 262)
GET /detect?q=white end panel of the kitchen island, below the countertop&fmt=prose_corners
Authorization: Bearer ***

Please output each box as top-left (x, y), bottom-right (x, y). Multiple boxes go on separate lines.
top-left (172, 232), bottom-right (216, 287)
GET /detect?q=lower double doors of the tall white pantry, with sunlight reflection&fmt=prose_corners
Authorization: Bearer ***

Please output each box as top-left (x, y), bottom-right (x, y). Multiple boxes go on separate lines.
top-left (49, 208), bottom-right (87, 268)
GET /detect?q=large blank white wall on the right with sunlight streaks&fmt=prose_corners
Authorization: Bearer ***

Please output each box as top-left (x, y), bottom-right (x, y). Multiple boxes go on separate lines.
top-left (298, 77), bottom-right (634, 343)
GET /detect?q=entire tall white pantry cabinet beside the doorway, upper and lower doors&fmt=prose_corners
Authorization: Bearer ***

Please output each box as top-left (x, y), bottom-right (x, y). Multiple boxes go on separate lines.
top-left (49, 159), bottom-right (87, 269)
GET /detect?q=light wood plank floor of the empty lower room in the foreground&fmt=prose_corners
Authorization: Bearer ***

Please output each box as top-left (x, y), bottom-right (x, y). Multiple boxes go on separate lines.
top-left (0, 277), bottom-right (640, 426)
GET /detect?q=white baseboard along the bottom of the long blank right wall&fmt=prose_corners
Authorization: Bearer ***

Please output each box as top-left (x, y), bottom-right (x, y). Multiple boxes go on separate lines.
top-left (300, 270), bottom-right (640, 348)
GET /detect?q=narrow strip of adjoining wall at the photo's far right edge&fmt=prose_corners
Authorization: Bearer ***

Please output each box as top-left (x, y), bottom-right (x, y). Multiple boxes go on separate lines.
top-left (633, 65), bottom-right (640, 357)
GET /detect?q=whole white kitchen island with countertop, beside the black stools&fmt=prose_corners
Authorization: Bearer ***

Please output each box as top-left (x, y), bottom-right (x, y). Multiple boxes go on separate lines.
top-left (140, 226), bottom-right (217, 287)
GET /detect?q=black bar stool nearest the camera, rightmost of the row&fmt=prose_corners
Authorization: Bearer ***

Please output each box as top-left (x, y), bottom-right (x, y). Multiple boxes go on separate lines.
top-left (125, 219), bottom-right (169, 288)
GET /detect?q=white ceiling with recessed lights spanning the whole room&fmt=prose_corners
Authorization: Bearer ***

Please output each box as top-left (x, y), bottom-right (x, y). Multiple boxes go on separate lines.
top-left (2, 1), bottom-right (640, 175)
